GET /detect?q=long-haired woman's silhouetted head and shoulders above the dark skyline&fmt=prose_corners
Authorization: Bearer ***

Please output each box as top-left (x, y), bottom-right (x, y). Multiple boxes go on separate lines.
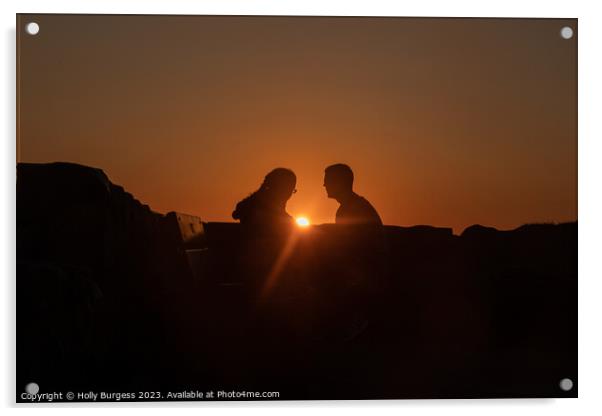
top-left (232, 168), bottom-right (297, 227)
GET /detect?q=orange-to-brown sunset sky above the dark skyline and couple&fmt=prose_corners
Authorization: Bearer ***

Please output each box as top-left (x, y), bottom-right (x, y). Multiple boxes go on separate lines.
top-left (17, 15), bottom-right (577, 233)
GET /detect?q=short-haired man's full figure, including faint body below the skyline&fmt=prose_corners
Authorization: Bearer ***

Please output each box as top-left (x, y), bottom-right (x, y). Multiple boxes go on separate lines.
top-left (324, 164), bottom-right (386, 342)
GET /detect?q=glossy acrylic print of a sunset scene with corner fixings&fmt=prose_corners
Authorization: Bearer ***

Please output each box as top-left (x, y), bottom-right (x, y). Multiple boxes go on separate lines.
top-left (15, 14), bottom-right (578, 402)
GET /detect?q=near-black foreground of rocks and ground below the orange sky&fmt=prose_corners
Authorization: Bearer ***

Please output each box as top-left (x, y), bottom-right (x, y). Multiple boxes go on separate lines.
top-left (16, 164), bottom-right (577, 401)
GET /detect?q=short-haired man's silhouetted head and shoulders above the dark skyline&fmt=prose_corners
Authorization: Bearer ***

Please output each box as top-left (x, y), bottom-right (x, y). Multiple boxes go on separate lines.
top-left (324, 163), bottom-right (383, 225)
